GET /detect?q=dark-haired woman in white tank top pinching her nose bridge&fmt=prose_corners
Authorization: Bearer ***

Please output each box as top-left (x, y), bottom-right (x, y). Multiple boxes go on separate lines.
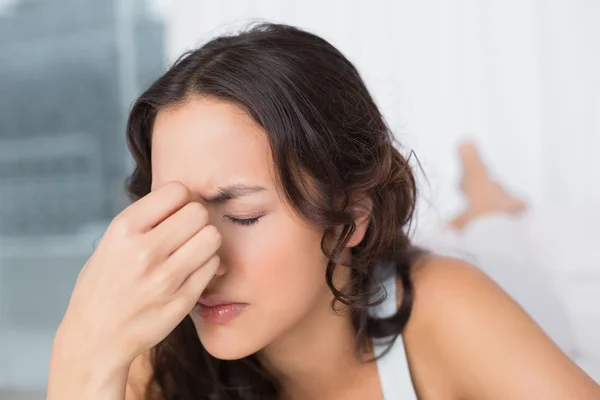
top-left (48, 24), bottom-right (600, 400)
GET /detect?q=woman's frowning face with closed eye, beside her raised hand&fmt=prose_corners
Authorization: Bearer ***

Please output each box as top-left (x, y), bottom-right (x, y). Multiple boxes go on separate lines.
top-left (152, 97), bottom-right (332, 359)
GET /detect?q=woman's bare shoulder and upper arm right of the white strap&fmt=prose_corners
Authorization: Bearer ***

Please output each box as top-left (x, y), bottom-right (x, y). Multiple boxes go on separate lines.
top-left (404, 256), bottom-right (600, 400)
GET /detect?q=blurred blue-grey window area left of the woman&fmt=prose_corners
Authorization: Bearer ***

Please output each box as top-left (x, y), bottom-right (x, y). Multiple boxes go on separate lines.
top-left (0, 0), bottom-right (165, 390)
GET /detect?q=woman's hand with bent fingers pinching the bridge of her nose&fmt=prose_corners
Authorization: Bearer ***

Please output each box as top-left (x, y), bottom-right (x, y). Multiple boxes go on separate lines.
top-left (53, 182), bottom-right (221, 367)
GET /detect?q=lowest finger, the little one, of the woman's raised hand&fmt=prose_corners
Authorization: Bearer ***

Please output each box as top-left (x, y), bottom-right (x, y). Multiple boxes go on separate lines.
top-left (167, 254), bottom-right (221, 314)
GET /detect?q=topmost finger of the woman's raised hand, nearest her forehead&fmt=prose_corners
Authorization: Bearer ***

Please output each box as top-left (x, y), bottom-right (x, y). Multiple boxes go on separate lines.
top-left (117, 181), bottom-right (197, 232)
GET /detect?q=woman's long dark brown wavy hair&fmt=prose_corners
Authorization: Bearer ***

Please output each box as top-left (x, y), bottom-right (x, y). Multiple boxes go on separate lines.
top-left (126, 23), bottom-right (420, 400)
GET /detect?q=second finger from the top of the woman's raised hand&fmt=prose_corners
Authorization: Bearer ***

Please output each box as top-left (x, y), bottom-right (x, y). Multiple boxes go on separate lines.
top-left (147, 202), bottom-right (208, 258)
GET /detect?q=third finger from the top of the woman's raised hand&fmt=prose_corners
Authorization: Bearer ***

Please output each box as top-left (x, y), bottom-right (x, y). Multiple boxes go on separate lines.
top-left (161, 225), bottom-right (221, 289)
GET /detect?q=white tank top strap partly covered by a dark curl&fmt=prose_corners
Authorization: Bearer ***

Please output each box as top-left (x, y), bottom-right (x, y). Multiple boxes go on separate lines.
top-left (371, 274), bottom-right (417, 400)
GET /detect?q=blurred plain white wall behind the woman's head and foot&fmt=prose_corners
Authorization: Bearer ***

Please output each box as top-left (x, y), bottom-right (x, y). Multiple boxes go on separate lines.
top-left (163, 0), bottom-right (600, 223)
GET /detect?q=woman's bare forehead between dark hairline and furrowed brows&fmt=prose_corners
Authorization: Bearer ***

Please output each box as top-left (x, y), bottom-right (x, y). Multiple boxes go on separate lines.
top-left (152, 98), bottom-right (273, 193)
